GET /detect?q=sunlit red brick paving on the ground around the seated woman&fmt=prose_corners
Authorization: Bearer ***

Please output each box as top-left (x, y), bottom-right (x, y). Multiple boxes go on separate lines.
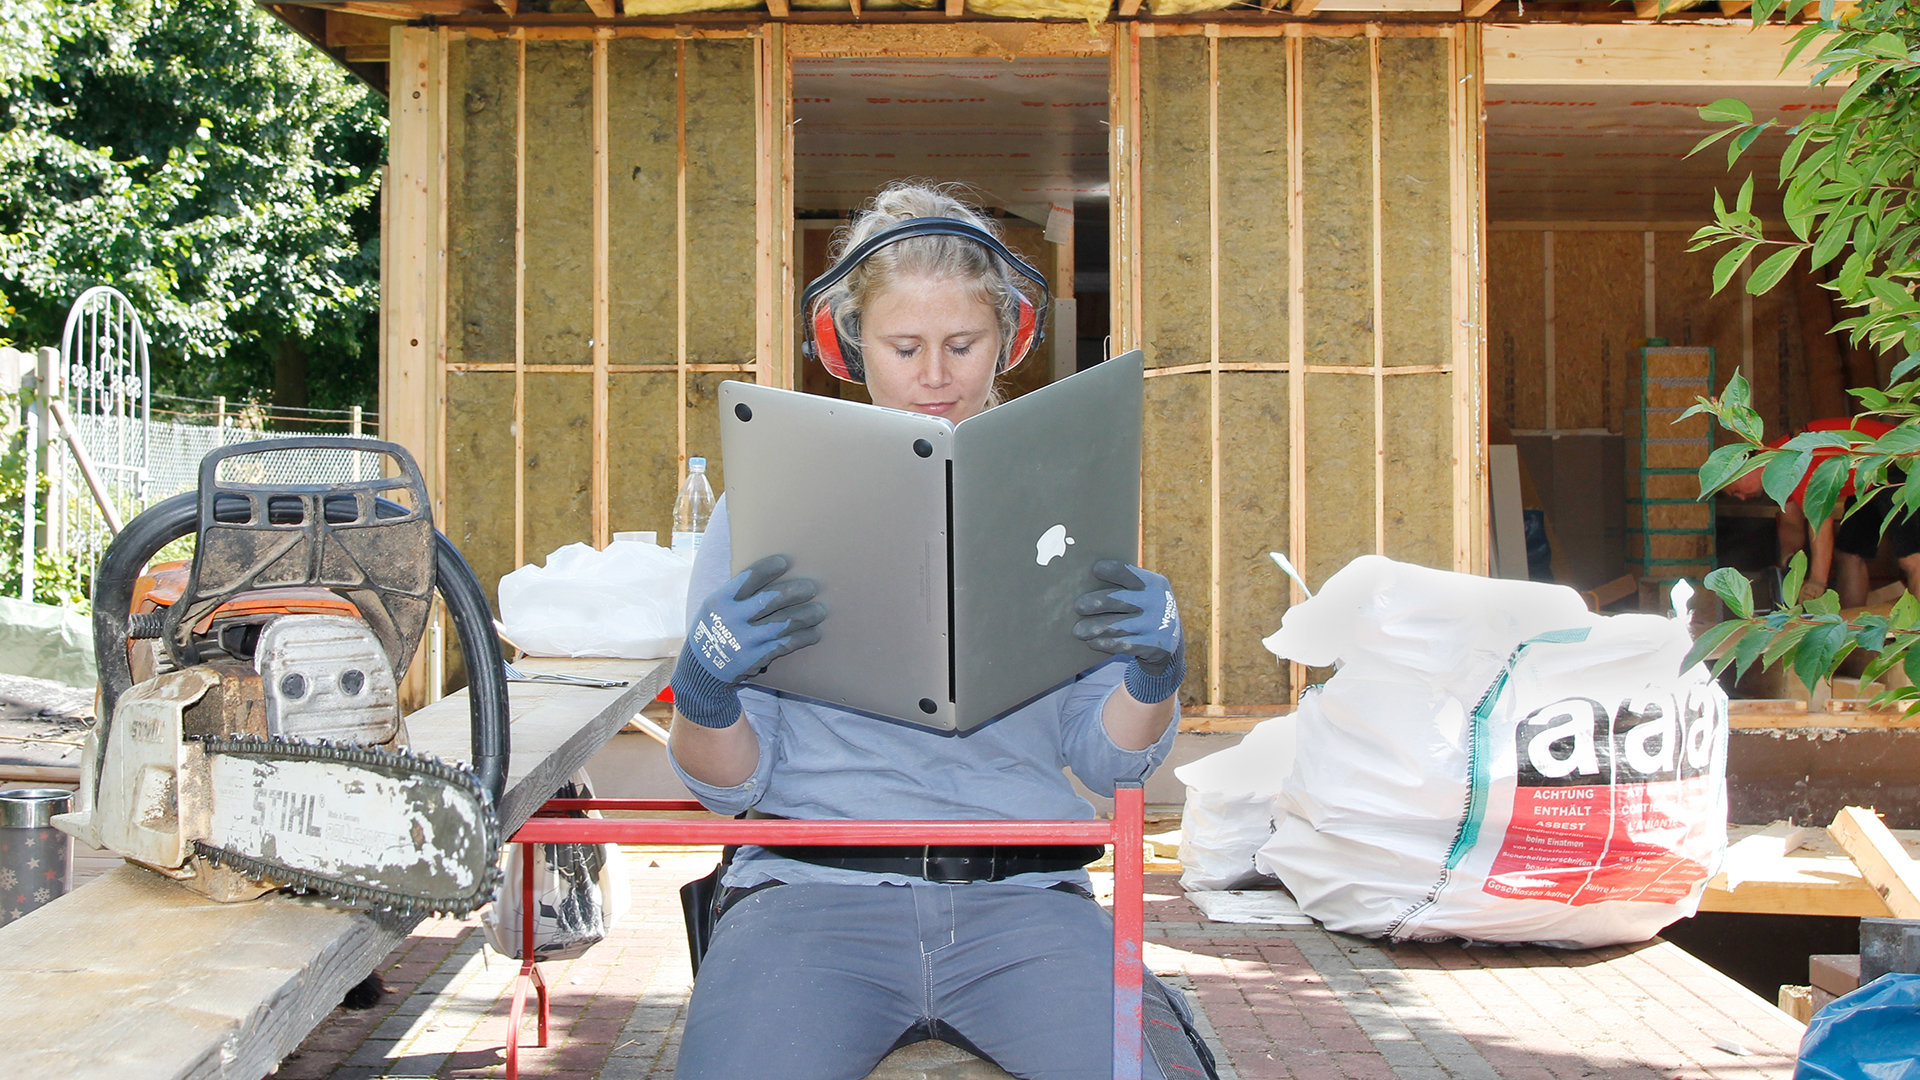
top-left (278, 851), bottom-right (1801, 1080)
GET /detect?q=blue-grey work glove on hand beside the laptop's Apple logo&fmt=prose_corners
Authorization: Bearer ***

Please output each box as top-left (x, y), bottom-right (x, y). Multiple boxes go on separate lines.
top-left (1073, 559), bottom-right (1187, 705)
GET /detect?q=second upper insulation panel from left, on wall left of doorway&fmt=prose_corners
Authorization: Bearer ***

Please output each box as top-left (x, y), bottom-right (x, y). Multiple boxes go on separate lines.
top-left (522, 40), bottom-right (593, 365)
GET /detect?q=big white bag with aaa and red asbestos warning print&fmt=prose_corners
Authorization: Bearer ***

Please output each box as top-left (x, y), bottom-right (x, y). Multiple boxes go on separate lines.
top-left (1254, 555), bottom-right (1726, 947)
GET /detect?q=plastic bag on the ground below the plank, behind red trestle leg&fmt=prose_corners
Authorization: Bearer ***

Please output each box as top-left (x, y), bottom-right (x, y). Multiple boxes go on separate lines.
top-left (480, 771), bottom-right (628, 961)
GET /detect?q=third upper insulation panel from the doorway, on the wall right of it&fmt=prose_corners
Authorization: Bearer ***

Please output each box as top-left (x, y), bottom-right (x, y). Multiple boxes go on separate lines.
top-left (1300, 38), bottom-right (1373, 367)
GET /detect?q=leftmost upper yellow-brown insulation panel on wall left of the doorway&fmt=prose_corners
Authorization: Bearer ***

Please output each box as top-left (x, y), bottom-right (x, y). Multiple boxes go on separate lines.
top-left (447, 38), bottom-right (520, 363)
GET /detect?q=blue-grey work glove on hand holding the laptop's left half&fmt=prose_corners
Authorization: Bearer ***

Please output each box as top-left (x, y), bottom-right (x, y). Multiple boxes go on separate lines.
top-left (674, 555), bottom-right (828, 728)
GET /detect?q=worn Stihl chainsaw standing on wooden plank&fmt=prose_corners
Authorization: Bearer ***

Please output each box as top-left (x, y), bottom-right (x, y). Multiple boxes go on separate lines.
top-left (54, 436), bottom-right (507, 915)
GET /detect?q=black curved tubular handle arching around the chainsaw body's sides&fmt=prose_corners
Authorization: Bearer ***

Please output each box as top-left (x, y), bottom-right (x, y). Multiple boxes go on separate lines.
top-left (94, 492), bottom-right (511, 805)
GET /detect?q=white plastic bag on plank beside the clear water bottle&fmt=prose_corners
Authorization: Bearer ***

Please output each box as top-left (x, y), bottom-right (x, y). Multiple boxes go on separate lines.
top-left (499, 540), bottom-right (693, 659)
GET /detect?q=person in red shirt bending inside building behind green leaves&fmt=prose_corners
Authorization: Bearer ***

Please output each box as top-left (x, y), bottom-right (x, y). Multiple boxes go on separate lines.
top-left (1724, 417), bottom-right (1920, 607)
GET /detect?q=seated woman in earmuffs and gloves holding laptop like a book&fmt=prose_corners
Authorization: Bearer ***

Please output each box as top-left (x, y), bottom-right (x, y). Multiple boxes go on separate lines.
top-left (670, 183), bottom-right (1212, 1080)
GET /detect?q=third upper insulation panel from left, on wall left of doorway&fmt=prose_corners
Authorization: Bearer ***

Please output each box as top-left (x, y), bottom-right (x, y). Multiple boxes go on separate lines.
top-left (607, 38), bottom-right (687, 365)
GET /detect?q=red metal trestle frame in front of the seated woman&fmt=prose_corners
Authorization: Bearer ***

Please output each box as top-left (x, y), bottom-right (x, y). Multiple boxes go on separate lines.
top-left (507, 782), bottom-right (1146, 1080)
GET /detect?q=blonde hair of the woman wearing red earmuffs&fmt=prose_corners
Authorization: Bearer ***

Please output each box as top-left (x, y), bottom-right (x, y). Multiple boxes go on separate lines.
top-left (804, 181), bottom-right (1025, 384)
